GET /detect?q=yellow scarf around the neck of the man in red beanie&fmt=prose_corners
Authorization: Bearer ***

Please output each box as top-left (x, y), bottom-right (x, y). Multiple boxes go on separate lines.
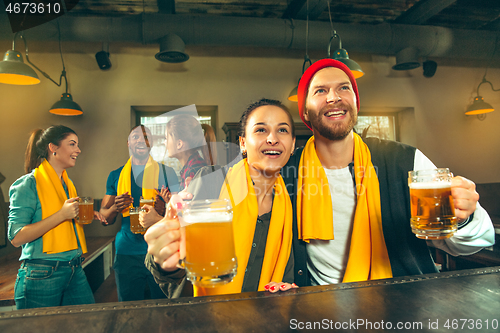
top-left (297, 133), bottom-right (392, 282)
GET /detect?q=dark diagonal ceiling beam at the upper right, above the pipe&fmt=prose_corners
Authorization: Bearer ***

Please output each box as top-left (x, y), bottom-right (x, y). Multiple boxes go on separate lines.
top-left (394, 0), bottom-right (457, 24)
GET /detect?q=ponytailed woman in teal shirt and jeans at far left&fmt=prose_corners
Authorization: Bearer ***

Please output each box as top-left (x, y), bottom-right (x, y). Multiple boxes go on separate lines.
top-left (8, 125), bottom-right (104, 309)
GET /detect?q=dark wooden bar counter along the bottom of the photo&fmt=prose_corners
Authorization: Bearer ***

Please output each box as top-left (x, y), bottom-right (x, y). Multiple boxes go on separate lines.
top-left (0, 266), bottom-right (500, 333)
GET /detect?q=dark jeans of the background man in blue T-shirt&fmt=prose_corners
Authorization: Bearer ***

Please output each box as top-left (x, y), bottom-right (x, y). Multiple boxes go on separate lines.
top-left (113, 254), bottom-right (167, 302)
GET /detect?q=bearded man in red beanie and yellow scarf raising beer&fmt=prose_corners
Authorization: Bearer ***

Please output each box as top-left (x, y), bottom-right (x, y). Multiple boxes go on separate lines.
top-left (282, 59), bottom-right (495, 286)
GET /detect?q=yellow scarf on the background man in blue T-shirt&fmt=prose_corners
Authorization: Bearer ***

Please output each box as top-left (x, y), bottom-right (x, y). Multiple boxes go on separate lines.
top-left (116, 156), bottom-right (160, 217)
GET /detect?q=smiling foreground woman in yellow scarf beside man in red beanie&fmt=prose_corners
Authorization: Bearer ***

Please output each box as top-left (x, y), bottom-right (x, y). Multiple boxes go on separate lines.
top-left (145, 99), bottom-right (296, 298)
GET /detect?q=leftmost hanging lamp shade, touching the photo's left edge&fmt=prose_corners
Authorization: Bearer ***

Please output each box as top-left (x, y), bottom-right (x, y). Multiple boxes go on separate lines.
top-left (0, 50), bottom-right (40, 85)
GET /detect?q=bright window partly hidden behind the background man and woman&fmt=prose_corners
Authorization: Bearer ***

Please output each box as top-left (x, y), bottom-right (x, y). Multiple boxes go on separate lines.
top-left (131, 105), bottom-right (217, 175)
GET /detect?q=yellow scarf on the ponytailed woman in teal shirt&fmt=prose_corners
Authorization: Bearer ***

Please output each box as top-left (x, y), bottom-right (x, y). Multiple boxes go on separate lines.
top-left (35, 160), bottom-right (87, 254)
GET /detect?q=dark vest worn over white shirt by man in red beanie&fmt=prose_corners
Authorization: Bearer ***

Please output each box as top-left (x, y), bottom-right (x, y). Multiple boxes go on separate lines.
top-left (282, 138), bottom-right (437, 286)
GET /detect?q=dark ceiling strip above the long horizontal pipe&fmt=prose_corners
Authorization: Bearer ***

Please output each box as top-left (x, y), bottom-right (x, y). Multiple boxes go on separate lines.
top-left (71, 0), bottom-right (500, 31)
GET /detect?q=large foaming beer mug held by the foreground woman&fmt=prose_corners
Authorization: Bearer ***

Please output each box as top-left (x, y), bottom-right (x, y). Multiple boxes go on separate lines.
top-left (178, 199), bottom-right (238, 287)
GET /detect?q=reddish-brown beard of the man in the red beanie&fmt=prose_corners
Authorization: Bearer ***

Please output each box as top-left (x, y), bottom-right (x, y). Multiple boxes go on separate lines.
top-left (309, 104), bottom-right (358, 141)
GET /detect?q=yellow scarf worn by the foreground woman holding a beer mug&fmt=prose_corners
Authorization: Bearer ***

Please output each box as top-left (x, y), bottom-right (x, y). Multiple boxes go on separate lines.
top-left (194, 159), bottom-right (292, 296)
